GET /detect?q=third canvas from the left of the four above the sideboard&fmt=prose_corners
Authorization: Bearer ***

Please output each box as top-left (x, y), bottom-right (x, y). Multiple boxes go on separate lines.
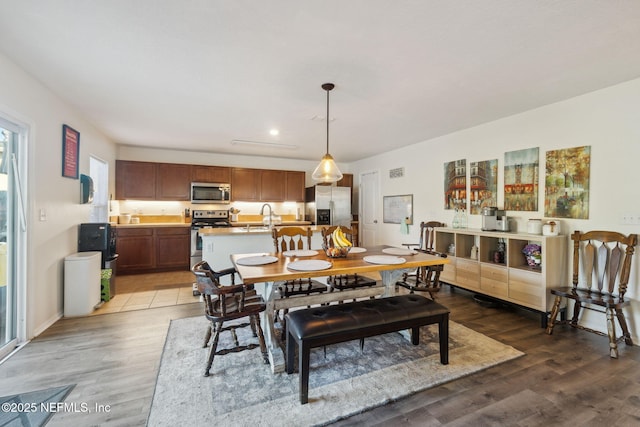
top-left (504, 147), bottom-right (540, 211)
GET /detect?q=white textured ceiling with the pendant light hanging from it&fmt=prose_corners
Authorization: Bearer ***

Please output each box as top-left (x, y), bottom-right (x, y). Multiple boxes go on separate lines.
top-left (0, 0), bottom-right (640, 162)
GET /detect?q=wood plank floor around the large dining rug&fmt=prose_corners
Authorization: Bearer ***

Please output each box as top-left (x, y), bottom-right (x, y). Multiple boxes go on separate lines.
top-left (0, 286), bottom-right (640, 426)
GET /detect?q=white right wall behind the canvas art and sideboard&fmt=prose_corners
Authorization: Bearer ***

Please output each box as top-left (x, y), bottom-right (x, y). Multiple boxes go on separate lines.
top-left (350, 75), bottom-right (640, 340)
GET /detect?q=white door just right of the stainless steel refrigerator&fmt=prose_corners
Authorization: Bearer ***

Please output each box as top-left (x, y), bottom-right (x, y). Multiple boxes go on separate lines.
top-left (359, 171), bottom-right (381, 246)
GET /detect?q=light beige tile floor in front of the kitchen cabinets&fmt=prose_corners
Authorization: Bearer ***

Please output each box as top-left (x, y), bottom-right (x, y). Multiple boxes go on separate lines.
top-left (92, 271), bottom-right (200, 315)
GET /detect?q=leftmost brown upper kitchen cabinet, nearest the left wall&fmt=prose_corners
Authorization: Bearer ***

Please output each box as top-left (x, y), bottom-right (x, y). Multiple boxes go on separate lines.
top-left (116, 160), bottom-right (157, 200)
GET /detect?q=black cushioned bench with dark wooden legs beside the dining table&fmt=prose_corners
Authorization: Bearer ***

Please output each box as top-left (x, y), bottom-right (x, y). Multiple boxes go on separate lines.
top-left (286, 295), bottom-right (449, 404)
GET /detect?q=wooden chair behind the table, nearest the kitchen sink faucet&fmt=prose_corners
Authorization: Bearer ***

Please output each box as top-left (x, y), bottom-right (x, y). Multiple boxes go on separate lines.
top-left (272, 226), bottom-right (328, 336)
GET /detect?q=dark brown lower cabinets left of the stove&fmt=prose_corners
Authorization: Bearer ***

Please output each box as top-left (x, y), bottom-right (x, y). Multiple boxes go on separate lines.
top-left (116, 226), bottom-right (190, 274)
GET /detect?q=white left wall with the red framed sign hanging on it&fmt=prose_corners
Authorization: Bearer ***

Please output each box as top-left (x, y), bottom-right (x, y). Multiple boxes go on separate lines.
top-left (0, 55), bottom-right (116, 338)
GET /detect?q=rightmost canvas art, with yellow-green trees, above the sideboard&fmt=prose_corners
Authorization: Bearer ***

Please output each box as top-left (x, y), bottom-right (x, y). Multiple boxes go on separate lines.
top-left (544, 146), bottom-right (591, 219)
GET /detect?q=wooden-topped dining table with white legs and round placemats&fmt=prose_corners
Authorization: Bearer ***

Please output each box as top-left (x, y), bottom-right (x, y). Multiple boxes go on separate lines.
top-left (231, 246), bottom-right (449, 373)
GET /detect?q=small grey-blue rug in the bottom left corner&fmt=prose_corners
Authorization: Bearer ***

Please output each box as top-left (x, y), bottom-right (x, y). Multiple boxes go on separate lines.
top-left (0, 384), bottom-right (75, 427)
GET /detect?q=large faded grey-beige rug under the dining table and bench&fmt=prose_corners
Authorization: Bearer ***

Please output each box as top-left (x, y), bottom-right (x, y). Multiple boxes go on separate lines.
top-left (147, 316), bottom-right (524, 427)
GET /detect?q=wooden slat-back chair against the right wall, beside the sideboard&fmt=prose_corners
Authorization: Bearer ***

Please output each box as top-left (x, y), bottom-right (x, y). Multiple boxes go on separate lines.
top-left (546, 231), bottom-right (638, 359)
